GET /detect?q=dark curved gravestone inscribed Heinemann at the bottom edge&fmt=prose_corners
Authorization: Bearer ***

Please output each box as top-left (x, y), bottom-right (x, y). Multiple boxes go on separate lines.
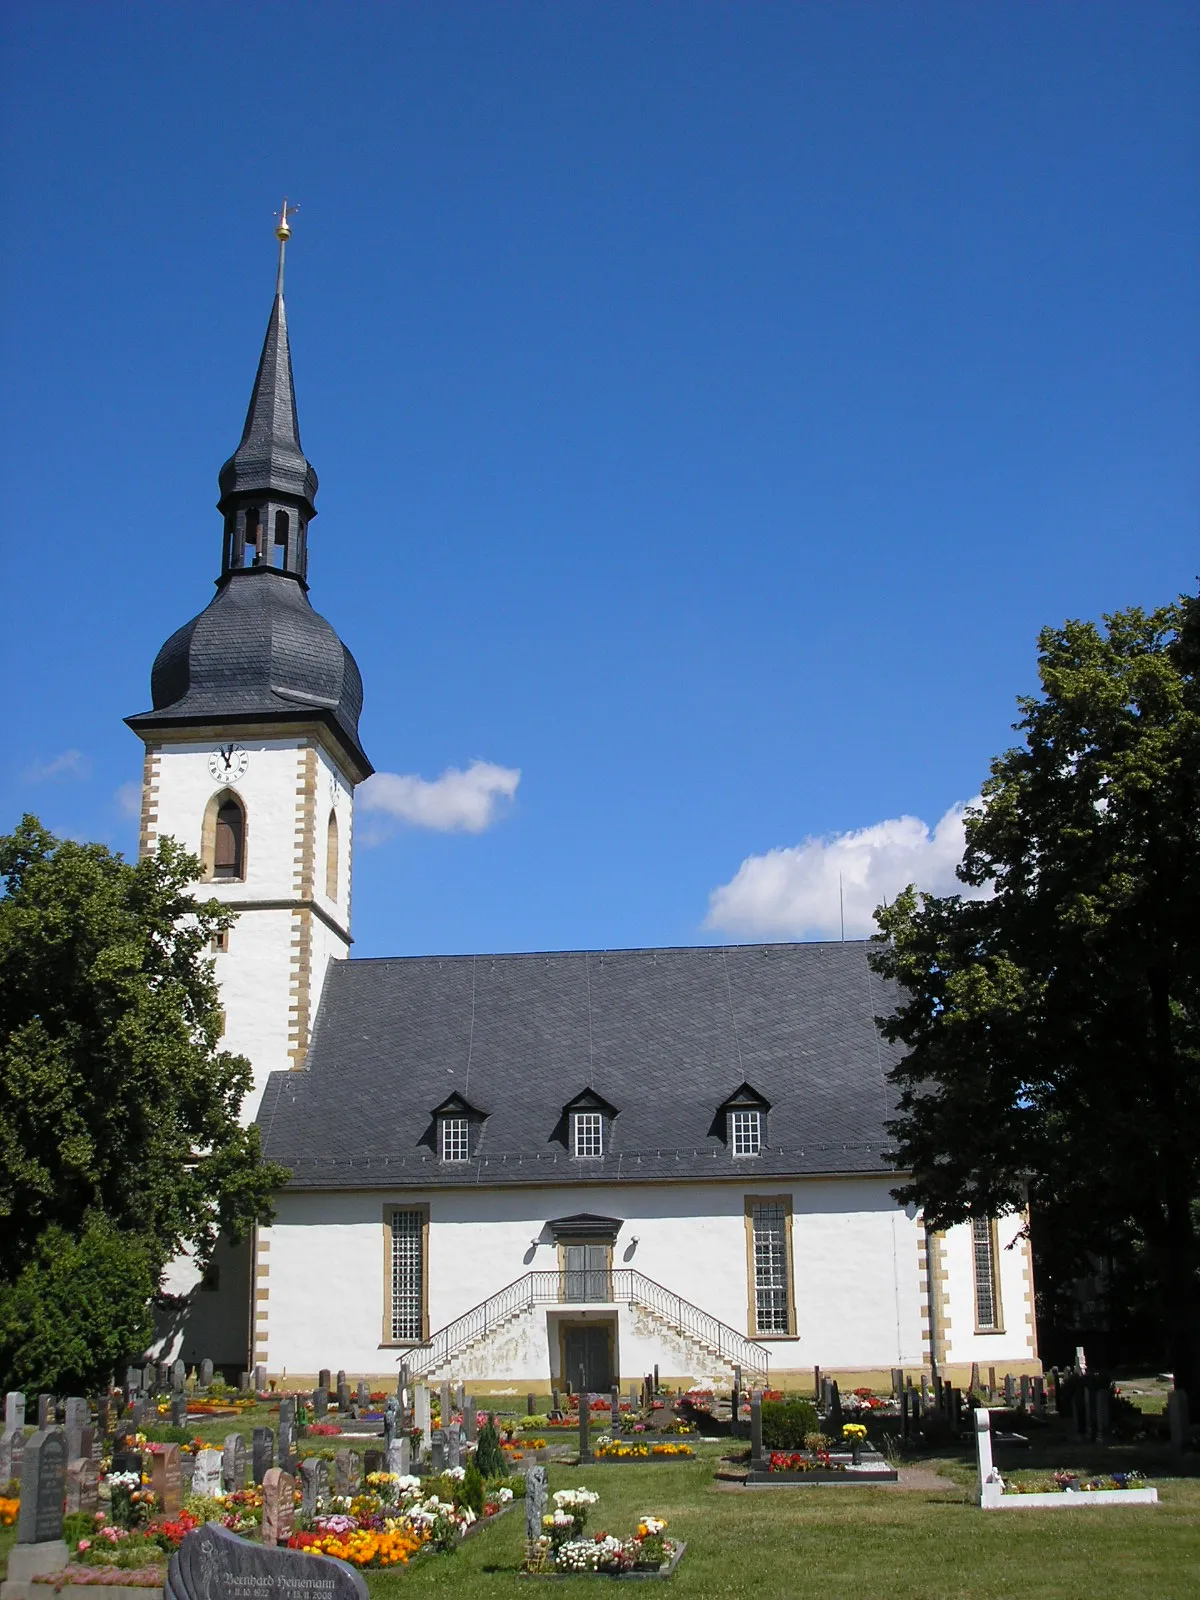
top-left (165, 1522), bottom-right (368, 1600)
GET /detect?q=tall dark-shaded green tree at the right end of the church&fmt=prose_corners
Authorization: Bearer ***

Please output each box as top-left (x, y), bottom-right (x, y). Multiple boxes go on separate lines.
top-left (872, 598), bottom-right (1200, 1398)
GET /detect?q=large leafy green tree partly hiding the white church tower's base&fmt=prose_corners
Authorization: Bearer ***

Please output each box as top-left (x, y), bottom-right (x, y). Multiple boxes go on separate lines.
top-left (0, 816), bottom-right (288, 1285)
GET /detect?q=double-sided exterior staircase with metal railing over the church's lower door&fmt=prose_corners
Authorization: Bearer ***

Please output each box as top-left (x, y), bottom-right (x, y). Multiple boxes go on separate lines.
top-left (405, 1267), bottom-right (771, 1384)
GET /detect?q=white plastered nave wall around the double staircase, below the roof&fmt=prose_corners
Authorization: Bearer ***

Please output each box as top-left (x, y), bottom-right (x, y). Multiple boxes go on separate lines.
top-left (259, 1178), bottom-right (940, 1384)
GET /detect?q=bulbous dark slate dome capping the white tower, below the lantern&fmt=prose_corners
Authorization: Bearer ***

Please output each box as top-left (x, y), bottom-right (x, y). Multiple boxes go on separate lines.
top-left (125, 566), bottom-right (373, 778)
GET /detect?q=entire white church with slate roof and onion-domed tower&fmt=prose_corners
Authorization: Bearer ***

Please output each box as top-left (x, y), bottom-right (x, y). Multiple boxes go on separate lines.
top-left (128, 222), bottom-right (1040, 1392)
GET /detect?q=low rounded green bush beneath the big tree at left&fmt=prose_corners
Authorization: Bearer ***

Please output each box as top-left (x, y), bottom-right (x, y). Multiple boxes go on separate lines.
top-left (0, 1216), bottom-right (155, 1394)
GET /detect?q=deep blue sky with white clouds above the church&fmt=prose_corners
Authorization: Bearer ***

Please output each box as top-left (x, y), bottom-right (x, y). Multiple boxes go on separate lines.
top-left (0, 0), bottom-right (1200, 955)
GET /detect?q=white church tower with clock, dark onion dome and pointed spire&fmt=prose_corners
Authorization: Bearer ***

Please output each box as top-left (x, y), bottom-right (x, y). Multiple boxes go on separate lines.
top-left (126, 202), bottom-right (371, 1120)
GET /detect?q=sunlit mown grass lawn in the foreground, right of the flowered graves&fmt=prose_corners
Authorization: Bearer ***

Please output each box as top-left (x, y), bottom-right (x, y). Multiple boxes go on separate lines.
top-left (366, 1454), bottom-right (1200, 1600)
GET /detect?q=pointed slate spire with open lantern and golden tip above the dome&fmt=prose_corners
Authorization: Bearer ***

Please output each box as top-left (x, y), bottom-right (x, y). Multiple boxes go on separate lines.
top-left (218, 200), bottom-right (317, 582)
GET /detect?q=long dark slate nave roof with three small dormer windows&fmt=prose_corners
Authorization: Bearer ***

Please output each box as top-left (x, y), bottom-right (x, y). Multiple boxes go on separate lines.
top-left (258, 941), bottom-right (898, 1189)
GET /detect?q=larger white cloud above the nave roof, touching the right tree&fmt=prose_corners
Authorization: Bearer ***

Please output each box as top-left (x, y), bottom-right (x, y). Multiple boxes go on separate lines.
top-left (704, 798), bottom-right (984, 939)
